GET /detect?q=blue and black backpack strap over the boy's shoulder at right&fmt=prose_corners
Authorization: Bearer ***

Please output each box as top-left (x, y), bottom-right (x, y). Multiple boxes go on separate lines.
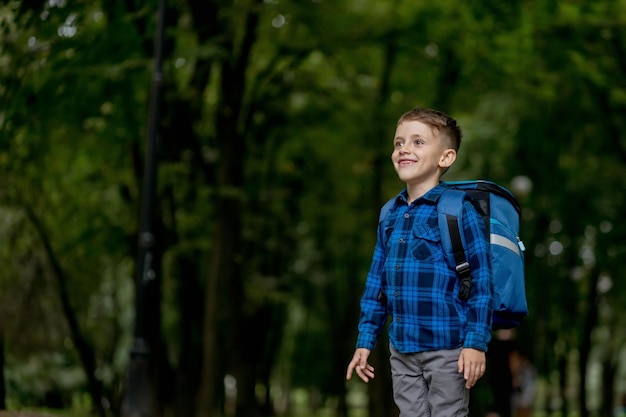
top-left (437, 190), bottom-right (472, 301)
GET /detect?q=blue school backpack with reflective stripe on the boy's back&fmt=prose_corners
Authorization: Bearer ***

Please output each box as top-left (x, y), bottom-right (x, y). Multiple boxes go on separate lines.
top-left (379, 180), bottom-right (528, 330)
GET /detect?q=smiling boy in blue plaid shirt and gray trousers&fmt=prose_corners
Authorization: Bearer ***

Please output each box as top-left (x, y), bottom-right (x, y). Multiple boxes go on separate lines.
top-left (346, 108), bottom-right (493, 417)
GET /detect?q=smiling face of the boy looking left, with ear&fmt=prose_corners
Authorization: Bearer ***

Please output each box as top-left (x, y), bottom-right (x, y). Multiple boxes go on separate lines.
top-left (391, 120), bottom-right (456, 190)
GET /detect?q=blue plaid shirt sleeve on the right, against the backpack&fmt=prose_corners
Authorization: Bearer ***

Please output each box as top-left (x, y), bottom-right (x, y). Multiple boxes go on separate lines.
top-left (462, 200), bottom-right (493, 352)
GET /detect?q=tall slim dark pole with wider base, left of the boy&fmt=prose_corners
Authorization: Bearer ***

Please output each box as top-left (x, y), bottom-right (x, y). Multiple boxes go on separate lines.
top-left (121, 0), bottom-right (165, 417)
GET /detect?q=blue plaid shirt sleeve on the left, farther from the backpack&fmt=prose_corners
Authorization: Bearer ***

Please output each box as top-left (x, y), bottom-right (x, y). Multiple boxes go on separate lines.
top-left (356, 225), bottom-right (387, 350)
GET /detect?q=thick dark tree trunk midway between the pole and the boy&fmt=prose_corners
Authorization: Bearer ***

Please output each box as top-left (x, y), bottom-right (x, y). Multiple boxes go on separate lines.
top-left (196, 0), bottom-right (261, 417)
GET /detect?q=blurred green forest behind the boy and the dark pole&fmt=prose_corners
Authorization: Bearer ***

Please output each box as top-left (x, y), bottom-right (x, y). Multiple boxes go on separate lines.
top-left (0, 0), bottom-right (626, 417)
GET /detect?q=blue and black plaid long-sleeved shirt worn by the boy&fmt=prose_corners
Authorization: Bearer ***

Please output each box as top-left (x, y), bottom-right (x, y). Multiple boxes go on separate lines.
top-left (356, 184), bottom-right (493, 353)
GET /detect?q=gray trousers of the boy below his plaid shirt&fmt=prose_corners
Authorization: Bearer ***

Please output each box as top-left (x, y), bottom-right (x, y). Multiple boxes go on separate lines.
top-left (389, 346), bottom-right (470, 417)
